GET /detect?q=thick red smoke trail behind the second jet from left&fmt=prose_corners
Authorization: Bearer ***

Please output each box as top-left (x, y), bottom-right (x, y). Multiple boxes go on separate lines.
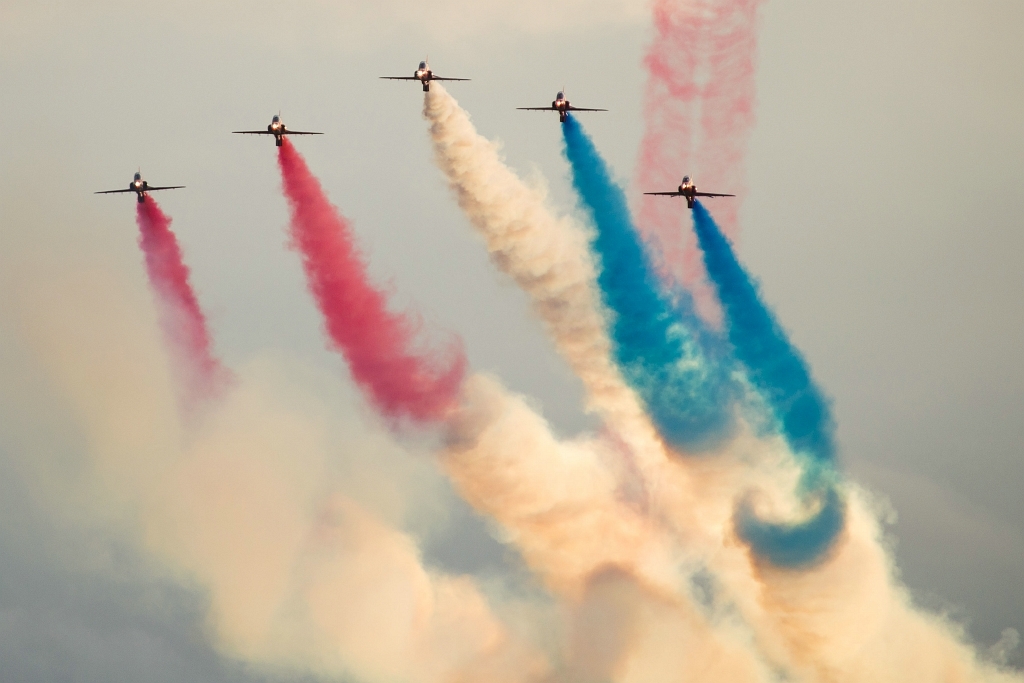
top-left (278, 139), bottom-right (466, 422)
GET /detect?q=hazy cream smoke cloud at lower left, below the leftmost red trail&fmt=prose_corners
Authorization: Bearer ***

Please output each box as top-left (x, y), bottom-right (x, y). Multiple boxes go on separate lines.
top-left (0, 245), bottom-right (550, 683)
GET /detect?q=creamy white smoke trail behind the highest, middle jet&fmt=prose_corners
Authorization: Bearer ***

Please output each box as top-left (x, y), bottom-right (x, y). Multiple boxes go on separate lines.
top-left (423, 83), bottom-right (665, 481)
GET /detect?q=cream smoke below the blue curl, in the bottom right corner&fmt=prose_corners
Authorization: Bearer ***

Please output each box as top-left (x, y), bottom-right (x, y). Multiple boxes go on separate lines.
top-left (720, 486), bottom-right (1024, 683)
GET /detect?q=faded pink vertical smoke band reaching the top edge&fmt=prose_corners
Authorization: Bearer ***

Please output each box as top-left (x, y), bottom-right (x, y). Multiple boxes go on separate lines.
top-left (637, 0), bottom-right (761, 299)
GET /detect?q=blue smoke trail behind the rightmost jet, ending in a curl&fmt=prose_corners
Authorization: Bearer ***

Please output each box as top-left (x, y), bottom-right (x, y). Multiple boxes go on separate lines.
top-left (693, 202), bottom-right (846, 566)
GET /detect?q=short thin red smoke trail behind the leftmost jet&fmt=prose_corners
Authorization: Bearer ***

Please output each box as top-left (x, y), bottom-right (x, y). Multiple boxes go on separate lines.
top-left (136, 197), bottom-right (230, 407)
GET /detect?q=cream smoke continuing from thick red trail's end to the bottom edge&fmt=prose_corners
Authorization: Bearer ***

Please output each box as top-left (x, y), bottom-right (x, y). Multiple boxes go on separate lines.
top-left (441, 376), bottom-right (772, 683)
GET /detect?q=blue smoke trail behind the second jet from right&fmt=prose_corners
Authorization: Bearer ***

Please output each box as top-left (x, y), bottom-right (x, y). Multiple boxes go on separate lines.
top-left (562, 116), bottom-right (738, 450)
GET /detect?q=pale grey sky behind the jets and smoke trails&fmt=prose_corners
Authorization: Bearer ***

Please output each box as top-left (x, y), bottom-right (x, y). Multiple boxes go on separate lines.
top-left (0, 0), bottom-right (1024, 683)
